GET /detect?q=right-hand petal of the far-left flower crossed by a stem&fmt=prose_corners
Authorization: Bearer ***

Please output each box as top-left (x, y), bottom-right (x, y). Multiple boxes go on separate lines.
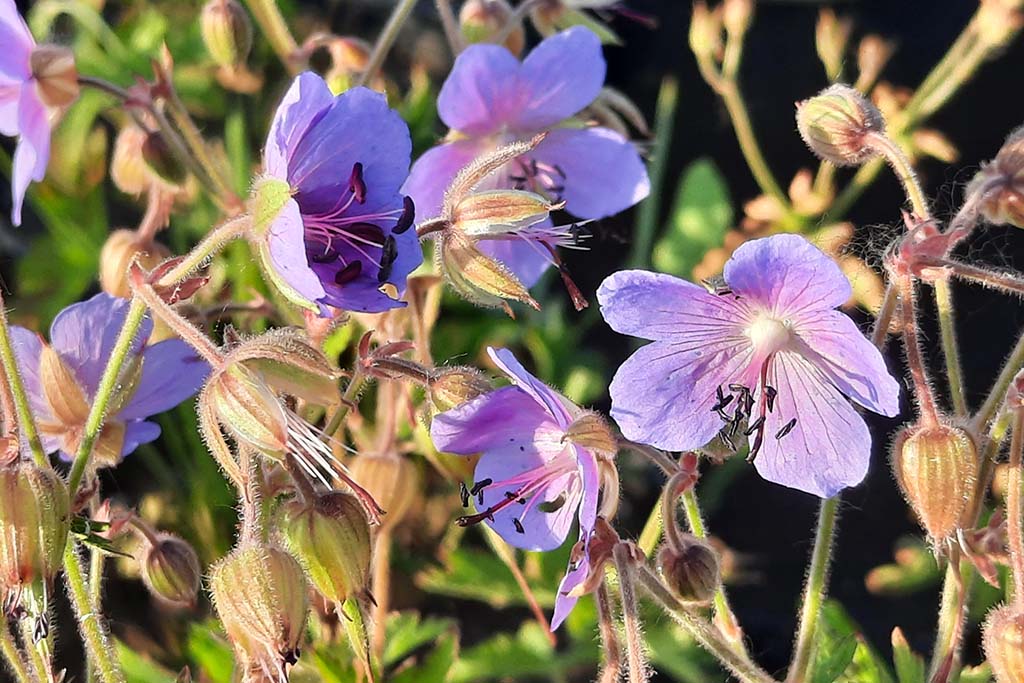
top-left (117, 339), bottom-right (210, 420)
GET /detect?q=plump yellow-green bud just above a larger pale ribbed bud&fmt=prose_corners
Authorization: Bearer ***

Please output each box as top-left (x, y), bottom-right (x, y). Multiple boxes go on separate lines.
top-left (282, 497), bottom-right (372, 604)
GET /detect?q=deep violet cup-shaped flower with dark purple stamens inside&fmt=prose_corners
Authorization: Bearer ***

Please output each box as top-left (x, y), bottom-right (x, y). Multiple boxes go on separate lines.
top-left (264, 72), bottom-right (423, 316)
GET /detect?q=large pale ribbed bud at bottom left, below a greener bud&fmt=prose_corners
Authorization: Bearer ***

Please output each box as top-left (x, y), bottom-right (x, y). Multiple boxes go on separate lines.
top-left (210, 546), bottom-right (309, 672)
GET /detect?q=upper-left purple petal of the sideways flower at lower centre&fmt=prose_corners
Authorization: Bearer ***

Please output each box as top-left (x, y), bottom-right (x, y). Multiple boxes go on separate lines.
top-left (430, 386), bottom-right (556, 456)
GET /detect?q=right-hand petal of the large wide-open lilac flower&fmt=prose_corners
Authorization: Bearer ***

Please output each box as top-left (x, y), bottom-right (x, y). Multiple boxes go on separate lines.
top-left (794, 310), bottom-right (900, 417)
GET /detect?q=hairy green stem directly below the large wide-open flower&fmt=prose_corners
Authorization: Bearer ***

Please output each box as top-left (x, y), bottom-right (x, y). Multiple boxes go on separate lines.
top-left (785, 496), bottom-right (840, 683)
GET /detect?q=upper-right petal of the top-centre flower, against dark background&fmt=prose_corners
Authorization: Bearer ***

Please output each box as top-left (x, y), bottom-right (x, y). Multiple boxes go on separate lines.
top-left (513, 27), bottom-right (605, 131)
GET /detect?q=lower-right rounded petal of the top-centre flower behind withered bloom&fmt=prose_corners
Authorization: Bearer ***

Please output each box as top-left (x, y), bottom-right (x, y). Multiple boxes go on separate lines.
top-left (534, 128), bottom-right (650, 218)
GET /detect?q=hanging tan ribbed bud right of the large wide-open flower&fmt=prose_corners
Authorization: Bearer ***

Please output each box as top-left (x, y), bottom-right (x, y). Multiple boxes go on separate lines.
top-left (893, 425), bottom-right (978, 543)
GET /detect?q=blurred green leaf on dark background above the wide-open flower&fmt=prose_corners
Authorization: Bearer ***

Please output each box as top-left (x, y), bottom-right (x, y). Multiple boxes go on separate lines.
top-left (652, 159), bottom-right (733, 278)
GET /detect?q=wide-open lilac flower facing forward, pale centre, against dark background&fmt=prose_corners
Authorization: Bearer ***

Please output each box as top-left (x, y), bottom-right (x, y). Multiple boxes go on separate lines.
top-left (597, 234), bottom-right (899, 498)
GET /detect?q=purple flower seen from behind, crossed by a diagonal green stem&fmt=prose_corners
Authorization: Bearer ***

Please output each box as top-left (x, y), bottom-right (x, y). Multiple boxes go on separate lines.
top-left (11, 294), bottom-right (210, 466)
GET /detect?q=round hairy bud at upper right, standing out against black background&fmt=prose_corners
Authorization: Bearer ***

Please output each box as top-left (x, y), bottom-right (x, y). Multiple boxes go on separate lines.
top-left (797, 84), bottom-right (885, 166)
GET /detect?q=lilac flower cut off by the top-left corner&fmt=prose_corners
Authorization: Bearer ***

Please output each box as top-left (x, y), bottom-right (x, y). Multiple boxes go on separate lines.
top-left (0, 0), bottom-right (78, 225)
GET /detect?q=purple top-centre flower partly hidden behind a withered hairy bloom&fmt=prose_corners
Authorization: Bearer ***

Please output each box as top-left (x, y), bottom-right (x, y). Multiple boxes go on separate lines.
top-left (402, 27), bottom-right (650, 287)
